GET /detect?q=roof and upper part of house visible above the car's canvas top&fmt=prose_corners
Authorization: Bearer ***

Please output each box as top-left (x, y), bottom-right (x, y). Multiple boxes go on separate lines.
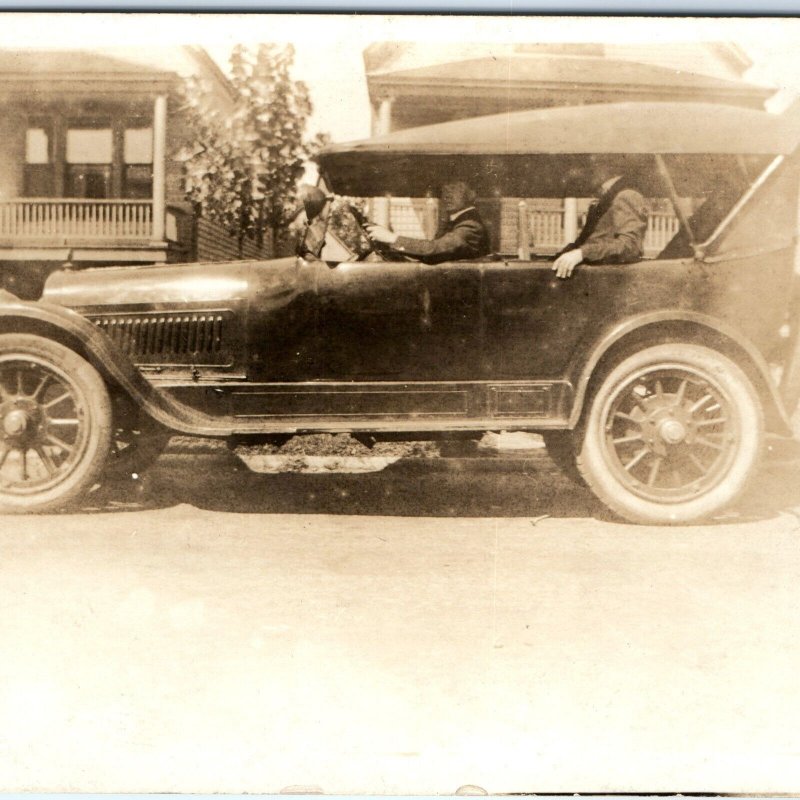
top-left (364, 42), bottom-right (775, 135)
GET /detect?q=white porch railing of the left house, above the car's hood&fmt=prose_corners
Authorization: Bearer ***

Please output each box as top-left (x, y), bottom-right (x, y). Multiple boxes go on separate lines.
top-left (0, 197), bottom-right (153, 242)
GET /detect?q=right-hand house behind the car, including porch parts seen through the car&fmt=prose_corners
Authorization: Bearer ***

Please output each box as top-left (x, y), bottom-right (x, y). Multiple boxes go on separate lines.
top-left (364, 42), bottom-right (775, 255)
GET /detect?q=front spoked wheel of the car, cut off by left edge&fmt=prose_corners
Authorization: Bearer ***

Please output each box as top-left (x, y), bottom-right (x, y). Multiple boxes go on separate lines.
top-left (0, 334), bottom-right (111, 513)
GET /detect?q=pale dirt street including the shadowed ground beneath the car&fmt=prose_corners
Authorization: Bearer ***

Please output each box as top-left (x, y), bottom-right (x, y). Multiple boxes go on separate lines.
top-left (0, 455), bottom-right (800, 793)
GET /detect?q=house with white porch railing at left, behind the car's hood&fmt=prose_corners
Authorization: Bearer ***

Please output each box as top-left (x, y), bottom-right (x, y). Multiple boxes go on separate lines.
top-left (0, 47), bottom-right (270, 295)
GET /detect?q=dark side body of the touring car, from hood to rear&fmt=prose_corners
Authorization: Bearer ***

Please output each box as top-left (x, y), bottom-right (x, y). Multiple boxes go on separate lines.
top-left (18, 219), bottom-right (793, 434)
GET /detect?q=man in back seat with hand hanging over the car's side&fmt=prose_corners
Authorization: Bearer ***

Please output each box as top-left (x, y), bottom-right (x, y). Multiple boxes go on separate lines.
top-left (553, 163), bottom-right (647, 278)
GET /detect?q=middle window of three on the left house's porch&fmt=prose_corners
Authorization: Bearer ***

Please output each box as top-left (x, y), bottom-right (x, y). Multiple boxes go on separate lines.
top-left (64, 125), bottom-right (114, 199)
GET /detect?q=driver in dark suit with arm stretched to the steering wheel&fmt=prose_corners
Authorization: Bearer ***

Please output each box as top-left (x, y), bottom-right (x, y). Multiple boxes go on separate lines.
top-left (366, 181), bottom-right (490, 264)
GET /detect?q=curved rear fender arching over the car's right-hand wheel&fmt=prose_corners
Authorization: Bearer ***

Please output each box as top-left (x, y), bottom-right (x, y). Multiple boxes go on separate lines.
top-left (569, 309), bottom-right (792, 436)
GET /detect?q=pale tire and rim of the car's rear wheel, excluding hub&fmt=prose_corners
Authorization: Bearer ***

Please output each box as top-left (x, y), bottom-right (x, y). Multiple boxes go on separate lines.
top-left (576, 342), bottom-right (764, 525)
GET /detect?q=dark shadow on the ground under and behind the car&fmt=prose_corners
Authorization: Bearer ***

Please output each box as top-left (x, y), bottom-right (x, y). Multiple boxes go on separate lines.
top-left (76, 454), bottom-right (800, 524)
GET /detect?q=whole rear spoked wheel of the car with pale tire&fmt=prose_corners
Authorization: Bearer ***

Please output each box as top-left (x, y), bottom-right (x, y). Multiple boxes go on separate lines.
top-left (577, 343), bottom-right (764, 524)
